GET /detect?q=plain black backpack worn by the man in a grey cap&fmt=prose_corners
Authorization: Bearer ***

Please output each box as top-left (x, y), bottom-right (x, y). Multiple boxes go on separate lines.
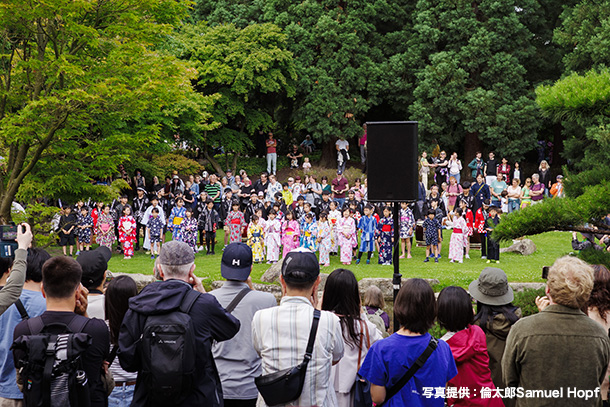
top-left (141, 290), bottom-right (200, 406)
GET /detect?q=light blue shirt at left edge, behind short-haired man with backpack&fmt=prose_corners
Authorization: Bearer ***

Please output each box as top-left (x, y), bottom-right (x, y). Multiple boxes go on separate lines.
top-left (0, 290), bottom-right (47, 399)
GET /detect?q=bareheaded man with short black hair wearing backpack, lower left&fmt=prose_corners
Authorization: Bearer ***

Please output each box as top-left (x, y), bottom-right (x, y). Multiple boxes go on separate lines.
top-left (13, 257), bottom-right (110, 407)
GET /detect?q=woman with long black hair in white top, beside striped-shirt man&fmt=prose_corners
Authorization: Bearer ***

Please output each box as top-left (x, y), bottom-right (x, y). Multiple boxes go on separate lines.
top-left (322, 269), bottom-right (382, 407)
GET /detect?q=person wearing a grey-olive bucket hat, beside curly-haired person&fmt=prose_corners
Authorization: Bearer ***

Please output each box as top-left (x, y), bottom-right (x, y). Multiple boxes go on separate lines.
top-left (468, 267), bottom-right (521, 407)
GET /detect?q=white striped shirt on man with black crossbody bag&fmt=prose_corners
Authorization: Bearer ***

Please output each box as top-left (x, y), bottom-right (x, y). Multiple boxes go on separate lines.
top-left (252, 296), bottom-right (343, 407)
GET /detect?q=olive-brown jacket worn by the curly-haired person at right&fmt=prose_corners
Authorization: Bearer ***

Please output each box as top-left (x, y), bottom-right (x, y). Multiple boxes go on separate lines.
top-left (502, 304), bottom-right (610, 407)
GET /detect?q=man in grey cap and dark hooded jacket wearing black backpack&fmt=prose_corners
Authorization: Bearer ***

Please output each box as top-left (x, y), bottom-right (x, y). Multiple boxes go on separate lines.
top-left (118, 240), bottom-right (240, 407)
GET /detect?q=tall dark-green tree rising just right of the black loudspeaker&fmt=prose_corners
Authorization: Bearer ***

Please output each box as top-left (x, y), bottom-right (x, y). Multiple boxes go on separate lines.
top-left (409, 0), bottom-right (540, 163)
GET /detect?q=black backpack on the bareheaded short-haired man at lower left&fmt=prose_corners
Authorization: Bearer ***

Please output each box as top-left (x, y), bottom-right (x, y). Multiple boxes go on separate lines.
top-left (12, 316), bottom-right (92, 407)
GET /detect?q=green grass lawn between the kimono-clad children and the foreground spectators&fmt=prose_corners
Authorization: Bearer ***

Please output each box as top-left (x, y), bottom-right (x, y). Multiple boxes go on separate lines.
top-left (69, 231), bottom-right (572, 290)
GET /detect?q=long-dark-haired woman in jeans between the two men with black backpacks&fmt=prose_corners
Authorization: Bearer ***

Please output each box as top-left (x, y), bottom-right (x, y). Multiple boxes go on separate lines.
top-left (104, 275), bottom-right (138, 407)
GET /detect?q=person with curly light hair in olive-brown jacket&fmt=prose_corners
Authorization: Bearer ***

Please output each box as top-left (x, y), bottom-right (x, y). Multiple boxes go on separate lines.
top-left (502, 256), bottom-right (610, 407)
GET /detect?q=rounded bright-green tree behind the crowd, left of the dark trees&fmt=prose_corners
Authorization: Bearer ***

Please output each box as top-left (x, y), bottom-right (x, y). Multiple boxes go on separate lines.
top-left (171, 23), bottom-right (297, 173)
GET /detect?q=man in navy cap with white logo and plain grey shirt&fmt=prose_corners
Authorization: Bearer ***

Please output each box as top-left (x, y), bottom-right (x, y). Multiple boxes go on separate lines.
top-left (210, 243), bottom-right (277, 407)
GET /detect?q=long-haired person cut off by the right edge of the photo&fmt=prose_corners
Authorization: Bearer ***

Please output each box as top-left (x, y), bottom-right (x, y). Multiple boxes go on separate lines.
top-left (587, 264), bottom-right (610, 407)
